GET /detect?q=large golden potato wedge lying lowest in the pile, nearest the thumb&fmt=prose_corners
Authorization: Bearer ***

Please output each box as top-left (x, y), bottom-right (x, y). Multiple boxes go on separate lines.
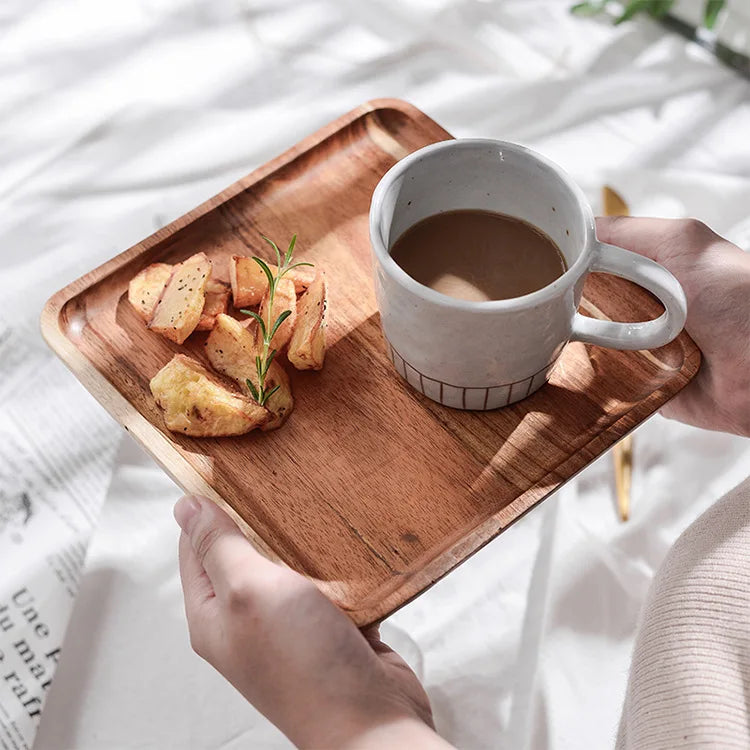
top-left (150, 354), bottom-right (270, 437)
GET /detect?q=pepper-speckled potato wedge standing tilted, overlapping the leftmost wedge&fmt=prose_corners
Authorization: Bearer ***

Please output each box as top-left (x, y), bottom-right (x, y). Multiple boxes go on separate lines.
top-left (148, 253), bottom-right (211, 344)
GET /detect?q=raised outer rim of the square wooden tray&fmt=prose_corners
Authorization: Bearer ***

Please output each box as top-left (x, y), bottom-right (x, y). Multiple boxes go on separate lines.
top-left (40, 98), bottom-right (701, 626)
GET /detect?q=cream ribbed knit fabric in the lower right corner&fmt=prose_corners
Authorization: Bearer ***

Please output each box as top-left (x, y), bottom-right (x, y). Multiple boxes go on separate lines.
top-left (617, 477), bottom-right (750, 750)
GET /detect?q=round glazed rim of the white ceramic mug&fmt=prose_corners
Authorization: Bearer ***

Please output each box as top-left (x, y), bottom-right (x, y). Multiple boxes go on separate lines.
top-left (370, 138), bottom-right (596, 312)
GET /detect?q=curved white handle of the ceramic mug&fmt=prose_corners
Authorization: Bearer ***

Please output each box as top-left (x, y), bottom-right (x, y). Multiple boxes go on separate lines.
top-left (570, 240), bottom-right (687, 349)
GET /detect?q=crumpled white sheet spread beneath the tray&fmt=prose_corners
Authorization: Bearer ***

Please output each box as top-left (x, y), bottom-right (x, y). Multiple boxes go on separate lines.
top-left (0, 0), bottom-right (750, 750)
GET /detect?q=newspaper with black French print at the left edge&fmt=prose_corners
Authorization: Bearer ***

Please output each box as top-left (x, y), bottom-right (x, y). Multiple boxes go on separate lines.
top-left (0, 319), bottom-right (120, 750)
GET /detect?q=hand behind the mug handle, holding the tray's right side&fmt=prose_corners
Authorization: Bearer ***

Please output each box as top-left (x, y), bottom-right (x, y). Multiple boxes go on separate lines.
top-left (596, 216), bottom-right (750, 436)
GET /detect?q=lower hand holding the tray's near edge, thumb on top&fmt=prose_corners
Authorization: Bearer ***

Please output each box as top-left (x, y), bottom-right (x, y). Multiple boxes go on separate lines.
top-left (174, 497), bottom-right (449, 749)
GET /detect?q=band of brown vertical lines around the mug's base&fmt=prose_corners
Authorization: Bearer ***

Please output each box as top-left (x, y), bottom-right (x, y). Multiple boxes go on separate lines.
top-left (387, 341), bottom-right (556, 411)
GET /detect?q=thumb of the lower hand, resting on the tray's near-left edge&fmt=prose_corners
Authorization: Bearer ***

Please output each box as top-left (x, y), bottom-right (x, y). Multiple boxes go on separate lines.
top-left (174, 497), bottom-right (277, 598)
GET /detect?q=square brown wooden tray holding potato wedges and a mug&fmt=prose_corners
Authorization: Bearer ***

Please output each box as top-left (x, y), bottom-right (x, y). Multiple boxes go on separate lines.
top-left (42, 100), bottom-right (700, 625)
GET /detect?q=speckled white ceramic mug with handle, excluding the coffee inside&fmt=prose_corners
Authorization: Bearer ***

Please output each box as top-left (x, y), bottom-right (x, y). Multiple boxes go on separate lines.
top-left (370, 138), bottom-right (687, 410)
